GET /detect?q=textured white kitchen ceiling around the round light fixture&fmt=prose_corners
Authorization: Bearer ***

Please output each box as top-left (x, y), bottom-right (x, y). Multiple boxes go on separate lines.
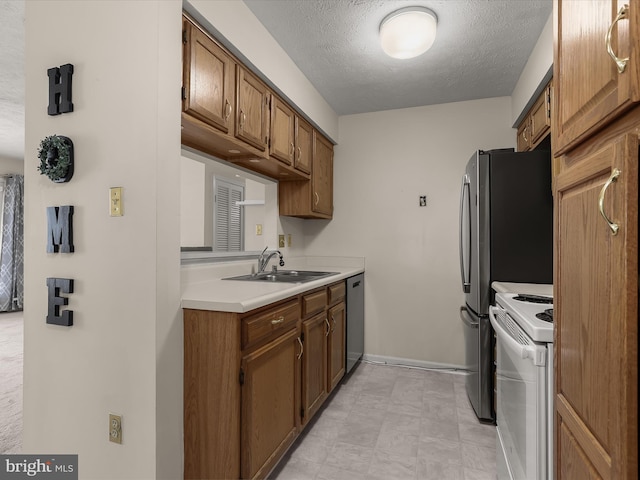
top-left (244, 0), bottom-right (552, 115)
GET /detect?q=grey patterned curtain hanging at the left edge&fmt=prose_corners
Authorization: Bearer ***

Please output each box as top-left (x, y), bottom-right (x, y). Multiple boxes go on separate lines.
top-left (0, 175), bottom-right (24, 312)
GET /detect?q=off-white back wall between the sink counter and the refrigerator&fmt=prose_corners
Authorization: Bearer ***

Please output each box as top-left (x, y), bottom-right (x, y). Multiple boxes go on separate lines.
top-left (304, 97), bottom-right (515, 365)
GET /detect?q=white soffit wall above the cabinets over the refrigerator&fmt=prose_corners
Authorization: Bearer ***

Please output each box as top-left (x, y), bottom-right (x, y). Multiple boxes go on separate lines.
top-left (511, 14), bottom-right (553, 125)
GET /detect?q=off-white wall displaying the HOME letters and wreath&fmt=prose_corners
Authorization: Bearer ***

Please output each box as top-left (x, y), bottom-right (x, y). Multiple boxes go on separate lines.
top-left (23, 0), bottom-right (182, 479)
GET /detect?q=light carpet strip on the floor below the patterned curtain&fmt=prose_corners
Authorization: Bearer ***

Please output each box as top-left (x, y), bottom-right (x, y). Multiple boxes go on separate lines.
top-left (0, 312), bottom-right (24, 454)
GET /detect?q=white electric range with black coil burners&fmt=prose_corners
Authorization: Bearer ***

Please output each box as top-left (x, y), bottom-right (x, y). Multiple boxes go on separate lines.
top-left (489, 293), bottom-right (553, 480)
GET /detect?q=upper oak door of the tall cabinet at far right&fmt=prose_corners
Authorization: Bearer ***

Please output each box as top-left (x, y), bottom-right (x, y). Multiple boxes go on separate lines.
top-left (553, 0), bottom-right (640, 153)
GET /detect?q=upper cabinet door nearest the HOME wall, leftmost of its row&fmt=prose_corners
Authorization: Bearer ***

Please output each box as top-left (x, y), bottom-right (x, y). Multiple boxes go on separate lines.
top-left (183, 20), bottom-right (235, 133)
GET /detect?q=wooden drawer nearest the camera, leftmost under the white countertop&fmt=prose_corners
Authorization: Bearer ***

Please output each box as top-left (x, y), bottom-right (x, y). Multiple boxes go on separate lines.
top-left (242, 300), bottom-right (299, 349)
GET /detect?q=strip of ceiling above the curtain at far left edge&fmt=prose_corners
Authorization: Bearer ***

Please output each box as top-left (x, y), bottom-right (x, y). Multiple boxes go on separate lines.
top-left (0, 0), bottom-right (24, 159)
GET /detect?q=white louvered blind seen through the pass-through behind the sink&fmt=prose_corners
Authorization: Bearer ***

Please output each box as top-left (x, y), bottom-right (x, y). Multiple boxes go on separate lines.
top-left (213, 178), bottom-right (244, 252)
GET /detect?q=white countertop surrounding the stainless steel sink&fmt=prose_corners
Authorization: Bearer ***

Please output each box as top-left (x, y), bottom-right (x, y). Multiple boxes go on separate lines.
top-left (182, 257), bottom-right (364, 313)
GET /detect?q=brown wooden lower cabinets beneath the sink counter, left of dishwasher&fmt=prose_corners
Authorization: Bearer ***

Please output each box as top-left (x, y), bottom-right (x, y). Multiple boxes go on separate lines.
top-left (183, 281), bottom-right (346, 479)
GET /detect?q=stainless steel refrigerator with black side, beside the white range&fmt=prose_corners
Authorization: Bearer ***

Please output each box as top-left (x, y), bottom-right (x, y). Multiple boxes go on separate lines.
top-left (460, 149), bottom-right (553, 422)
